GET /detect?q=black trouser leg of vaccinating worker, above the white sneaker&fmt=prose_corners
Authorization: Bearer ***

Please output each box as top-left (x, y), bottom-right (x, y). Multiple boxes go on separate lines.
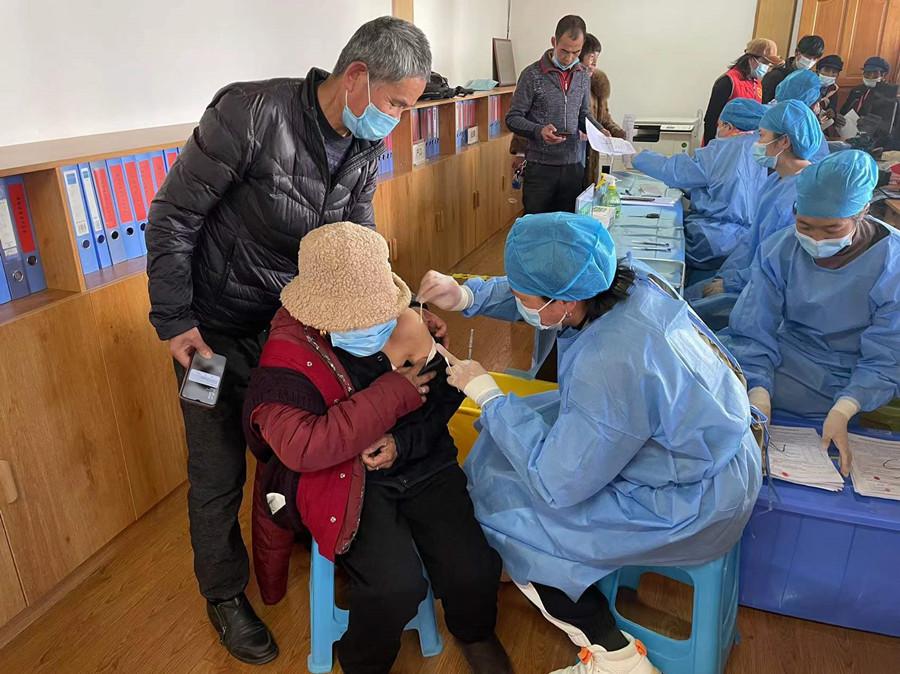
top-left (532, 583), bottom-right (628, 651)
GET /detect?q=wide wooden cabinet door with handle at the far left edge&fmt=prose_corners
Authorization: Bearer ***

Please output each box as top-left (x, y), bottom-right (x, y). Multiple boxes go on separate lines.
top-left (0, 294), bottom-right (135, 603)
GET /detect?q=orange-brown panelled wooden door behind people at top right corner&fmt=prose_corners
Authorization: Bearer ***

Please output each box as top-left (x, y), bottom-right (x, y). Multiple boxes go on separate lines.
top-left (798, 0), bottom-right (900, 87)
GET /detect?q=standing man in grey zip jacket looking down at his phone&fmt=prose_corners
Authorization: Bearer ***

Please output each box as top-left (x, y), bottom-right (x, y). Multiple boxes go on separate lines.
top-left (506, 14), bottom-right (603, 213)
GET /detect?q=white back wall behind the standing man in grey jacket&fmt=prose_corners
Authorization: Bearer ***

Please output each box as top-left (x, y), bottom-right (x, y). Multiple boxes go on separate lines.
top-left (510, 0), bottom-right (756, 123)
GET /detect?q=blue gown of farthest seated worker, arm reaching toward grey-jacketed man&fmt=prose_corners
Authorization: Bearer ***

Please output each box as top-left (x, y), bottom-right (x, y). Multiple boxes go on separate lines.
top-left (633, 133), bottom-right (767, 269)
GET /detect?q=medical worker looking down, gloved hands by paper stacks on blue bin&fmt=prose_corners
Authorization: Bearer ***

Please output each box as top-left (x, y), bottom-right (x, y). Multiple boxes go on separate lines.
top-left (724, 150), bottom-right (900, 475)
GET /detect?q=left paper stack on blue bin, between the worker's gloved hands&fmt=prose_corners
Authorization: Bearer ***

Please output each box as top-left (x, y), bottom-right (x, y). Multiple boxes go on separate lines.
top-left (769, 426), bottom-right (844, 491)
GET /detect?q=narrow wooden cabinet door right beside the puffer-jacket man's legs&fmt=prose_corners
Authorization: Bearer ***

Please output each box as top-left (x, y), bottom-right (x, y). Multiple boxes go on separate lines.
top-left (91, 274), bottom-right (187, 517)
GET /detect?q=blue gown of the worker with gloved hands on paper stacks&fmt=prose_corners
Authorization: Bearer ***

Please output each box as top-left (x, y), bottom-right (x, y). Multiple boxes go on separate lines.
top-left (723, 225), bottom-right (900, 417)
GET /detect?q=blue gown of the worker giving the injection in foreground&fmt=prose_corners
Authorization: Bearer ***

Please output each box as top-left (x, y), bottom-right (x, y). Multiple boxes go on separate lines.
top-left (465, 275), bottom-right (761, 599)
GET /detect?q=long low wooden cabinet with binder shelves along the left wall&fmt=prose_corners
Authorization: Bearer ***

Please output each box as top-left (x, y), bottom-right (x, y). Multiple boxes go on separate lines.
top-left (0, 87), bottom-right (521, 644)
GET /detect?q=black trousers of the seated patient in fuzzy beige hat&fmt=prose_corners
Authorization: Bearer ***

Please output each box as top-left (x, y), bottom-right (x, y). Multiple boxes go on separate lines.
top-left (337, 466), bottom-right (501, 674)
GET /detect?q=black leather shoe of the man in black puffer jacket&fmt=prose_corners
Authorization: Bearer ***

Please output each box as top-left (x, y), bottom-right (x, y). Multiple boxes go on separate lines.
top-left (206, 592), bottom-right (278, 665)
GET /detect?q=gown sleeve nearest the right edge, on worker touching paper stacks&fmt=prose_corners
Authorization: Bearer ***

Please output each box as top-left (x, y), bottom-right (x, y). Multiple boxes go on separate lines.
top-left (836, 270), bottom-right (900, 412)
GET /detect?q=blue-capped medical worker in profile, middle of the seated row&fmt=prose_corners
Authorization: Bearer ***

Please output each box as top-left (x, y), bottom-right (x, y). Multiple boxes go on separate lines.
top-left (685, 100), bottom-right (822, 330)
